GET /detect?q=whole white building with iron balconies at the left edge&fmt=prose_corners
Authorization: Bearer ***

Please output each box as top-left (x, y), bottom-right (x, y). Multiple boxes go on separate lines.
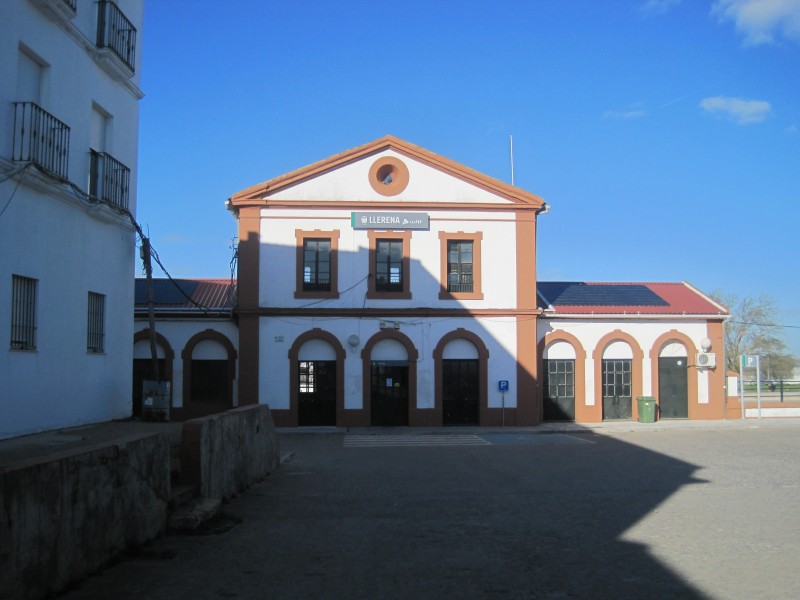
top-left (0, 0), bottom-right (144, 438)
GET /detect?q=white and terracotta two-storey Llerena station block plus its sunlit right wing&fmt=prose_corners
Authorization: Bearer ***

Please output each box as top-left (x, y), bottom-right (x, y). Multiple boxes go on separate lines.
top-left (229, 136), bottom-right (727, 426)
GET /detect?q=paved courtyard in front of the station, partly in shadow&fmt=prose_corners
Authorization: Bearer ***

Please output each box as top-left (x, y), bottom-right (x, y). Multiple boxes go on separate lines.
top-left (59, 422), bottom-right (800, 600)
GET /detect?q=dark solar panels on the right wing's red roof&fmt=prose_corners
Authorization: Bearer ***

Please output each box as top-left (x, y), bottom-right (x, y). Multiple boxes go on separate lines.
top-left (538, 282), bottom-right (669, 306)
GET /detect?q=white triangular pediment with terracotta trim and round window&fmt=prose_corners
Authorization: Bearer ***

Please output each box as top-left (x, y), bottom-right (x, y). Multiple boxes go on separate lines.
top-left (231, 136), bottom-right (545, 211)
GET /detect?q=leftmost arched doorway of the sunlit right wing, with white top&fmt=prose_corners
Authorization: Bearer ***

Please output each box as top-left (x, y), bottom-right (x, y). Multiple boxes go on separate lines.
top-left (542, 341), bottom-right (576, 421)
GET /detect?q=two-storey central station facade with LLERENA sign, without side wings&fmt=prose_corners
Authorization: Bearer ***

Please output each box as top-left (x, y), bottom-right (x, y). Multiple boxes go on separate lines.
top-left (230, 136), bottom-right (545, 426)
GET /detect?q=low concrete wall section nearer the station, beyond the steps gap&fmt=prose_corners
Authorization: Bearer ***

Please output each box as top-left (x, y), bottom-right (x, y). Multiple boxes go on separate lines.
top-left (181, 404), bottom-right (280, 499)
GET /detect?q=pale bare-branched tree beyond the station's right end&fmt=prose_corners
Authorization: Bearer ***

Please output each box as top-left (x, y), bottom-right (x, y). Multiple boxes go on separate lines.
top-left (711, 291), bottom-right (797, 379)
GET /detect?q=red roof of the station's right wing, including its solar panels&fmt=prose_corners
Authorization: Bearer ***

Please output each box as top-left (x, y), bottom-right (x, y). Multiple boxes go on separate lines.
top-left (538, 281), bottom-right (729, 316)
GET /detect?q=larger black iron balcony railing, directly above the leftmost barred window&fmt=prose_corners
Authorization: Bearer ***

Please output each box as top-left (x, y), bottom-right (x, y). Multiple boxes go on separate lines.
top-left (11, 102), bottom-right (69, 179)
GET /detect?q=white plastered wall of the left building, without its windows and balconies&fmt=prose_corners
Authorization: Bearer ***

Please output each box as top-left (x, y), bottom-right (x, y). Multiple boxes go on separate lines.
top-left (0, 0), bottom-right (143, 438)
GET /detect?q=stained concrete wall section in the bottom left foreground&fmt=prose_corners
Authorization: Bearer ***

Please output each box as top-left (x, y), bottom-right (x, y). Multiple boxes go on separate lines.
top-left (0, 434), bottom-right (170, 598)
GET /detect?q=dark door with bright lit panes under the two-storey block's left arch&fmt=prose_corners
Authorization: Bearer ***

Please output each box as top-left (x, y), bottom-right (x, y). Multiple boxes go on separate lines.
top-left (297, 360), bottom-right (336, 425)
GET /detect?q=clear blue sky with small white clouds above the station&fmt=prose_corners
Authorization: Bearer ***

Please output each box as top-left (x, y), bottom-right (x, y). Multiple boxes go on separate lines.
top-left (137, 0), bottom-right (800, 356)
